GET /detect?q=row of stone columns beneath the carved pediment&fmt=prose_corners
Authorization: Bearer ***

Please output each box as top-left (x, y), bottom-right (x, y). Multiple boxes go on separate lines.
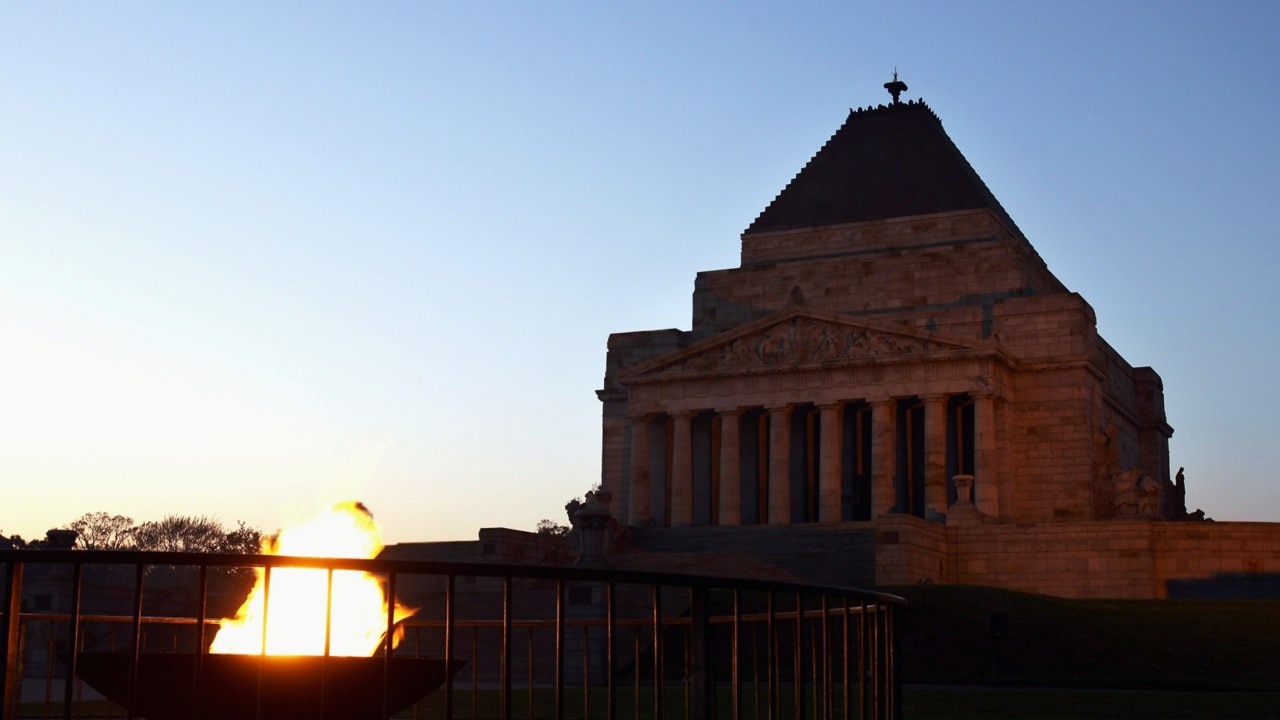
top-left (627, 395), bottom-right (997, 525)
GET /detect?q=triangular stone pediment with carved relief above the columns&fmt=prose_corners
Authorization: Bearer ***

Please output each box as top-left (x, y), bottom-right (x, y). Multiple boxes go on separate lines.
top-left (622, 309), bottom-right (975, 382)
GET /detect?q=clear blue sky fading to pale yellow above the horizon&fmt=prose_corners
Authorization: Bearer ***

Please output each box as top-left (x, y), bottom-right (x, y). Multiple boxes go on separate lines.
top-left (0, 0), bottom-right (1280, 542)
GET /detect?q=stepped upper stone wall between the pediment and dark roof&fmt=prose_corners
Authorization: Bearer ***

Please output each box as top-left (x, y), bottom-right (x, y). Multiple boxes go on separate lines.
top-left (692, 210), bottom-right (1066, 338)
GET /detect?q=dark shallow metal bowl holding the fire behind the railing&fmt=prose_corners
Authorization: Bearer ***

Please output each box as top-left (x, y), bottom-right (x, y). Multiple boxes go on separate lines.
top-left (77, 652), bottom-right (463, 720)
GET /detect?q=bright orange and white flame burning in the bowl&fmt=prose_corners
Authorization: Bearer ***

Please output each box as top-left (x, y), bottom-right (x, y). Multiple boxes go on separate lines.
top-left (209, 502), bottom-right (413, 656)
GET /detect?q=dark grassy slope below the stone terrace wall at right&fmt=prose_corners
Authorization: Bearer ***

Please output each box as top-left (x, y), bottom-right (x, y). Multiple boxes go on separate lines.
top-left (879, 585), bottom-right (1280, 692)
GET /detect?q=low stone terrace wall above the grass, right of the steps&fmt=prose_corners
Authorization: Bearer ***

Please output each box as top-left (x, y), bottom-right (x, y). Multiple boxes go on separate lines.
top-left (876, 516), bottom-right (1280, 600)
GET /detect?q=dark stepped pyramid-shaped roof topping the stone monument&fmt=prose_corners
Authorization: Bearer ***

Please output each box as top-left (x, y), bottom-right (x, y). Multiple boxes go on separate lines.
top-left (745, 100), bottom-right (1020, 234)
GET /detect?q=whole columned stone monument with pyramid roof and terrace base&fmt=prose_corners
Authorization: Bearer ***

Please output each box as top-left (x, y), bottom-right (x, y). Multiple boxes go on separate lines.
top-left (586, 78), bottom-right (1280, 597)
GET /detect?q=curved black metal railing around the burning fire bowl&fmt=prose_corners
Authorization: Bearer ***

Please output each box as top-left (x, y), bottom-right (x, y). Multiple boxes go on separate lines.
top-left (0, 551), bottom-right (902, 720)
